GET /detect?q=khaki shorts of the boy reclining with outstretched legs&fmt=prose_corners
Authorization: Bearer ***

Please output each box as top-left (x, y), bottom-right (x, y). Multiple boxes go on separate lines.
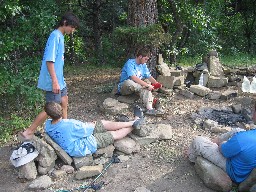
top-left (93, 121), bottom-right (114, 149)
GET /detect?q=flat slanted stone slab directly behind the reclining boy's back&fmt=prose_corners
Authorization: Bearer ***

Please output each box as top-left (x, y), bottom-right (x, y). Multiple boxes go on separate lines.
top-left (45, 134), bottom-right (73, 165)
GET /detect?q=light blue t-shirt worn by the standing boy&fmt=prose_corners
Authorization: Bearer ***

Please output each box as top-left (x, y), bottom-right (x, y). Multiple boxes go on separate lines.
top-left (37, 29), bottom-right (66, 91)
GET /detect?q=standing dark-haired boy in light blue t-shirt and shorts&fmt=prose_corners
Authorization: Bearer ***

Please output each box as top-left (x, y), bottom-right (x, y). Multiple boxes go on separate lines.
top-left (18, 13), bottom-right (79, 140)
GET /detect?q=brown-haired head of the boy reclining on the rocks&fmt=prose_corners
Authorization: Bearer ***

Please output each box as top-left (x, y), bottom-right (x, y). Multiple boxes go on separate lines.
top-left (44, 102), bottom-right (62, 120)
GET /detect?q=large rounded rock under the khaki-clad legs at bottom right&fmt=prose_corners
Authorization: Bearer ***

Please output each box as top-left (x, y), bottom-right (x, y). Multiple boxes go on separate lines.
top-left (195, 156), bottom-right (232, 192)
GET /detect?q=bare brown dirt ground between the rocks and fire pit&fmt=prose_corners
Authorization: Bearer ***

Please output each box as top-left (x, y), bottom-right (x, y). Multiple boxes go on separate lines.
top-left (0, 70), bottom-right (241, 192)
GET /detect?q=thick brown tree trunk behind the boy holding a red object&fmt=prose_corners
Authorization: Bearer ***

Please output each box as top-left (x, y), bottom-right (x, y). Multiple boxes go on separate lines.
top-left (127, 0), bottom-right (158, 78)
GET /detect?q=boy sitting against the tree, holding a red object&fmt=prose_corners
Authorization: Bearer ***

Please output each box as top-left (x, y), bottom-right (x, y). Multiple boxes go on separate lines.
top-left (118, 48), bottom-right (163, 115)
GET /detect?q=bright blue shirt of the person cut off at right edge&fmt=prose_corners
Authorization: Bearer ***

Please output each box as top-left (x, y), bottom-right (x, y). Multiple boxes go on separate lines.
top-left (221, 130), bottom-right (256, 183)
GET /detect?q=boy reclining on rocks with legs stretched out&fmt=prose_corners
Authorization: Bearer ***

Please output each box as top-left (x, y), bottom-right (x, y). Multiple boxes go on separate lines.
top-left (44, 102), bottom-right (143, 157)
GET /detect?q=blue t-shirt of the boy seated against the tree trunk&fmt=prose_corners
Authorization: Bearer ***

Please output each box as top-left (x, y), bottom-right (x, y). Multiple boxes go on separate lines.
top-left (118, 59), bottom-right (151, 91)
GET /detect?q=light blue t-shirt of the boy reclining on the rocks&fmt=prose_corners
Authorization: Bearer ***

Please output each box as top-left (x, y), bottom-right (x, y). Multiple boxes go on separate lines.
top-left (45, 119), bottom-right (97, 157)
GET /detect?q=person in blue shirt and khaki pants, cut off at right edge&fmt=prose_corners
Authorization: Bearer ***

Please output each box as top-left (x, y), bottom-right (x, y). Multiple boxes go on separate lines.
top-left (187, 128), bottom-right (256, 184)
